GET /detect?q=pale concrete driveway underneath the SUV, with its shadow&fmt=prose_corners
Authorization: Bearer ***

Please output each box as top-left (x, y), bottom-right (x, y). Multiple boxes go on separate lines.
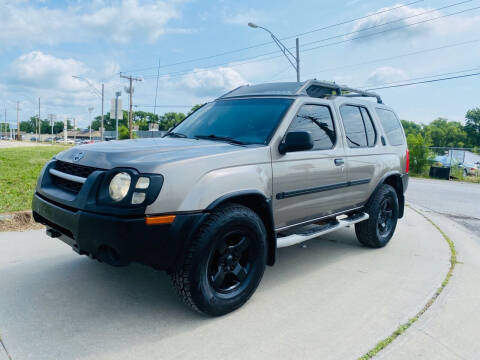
top-left (0, 209), bottom-right (449, 360)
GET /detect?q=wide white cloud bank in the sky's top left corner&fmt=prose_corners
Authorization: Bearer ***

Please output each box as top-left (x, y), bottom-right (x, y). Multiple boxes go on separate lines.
top-left (0, 0), bottom-right (187, 49)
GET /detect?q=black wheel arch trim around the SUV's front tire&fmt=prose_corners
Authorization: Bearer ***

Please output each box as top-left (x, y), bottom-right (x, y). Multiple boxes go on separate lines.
top-left (207, 190), bottom-right (277, 266)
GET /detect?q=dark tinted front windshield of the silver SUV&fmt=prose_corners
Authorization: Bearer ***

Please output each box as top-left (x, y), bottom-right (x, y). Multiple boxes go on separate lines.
top-left (173, 98), bottom-right (293, 144)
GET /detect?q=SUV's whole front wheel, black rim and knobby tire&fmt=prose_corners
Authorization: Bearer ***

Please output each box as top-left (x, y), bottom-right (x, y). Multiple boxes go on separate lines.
top-left (171, 204), bottom-right (267, 316)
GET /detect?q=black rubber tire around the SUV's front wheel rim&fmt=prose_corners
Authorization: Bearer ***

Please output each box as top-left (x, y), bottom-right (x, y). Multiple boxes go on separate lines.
top-left (171, 203), bottom-right (267, 316)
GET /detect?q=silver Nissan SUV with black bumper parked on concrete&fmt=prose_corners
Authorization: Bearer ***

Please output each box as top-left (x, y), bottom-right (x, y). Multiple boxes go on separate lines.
top-left (33, 80), bottom-right (409, 315)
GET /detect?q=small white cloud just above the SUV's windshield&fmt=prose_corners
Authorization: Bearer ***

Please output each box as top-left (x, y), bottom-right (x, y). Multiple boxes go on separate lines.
top-left (178, 67), bottom-right (248, 97)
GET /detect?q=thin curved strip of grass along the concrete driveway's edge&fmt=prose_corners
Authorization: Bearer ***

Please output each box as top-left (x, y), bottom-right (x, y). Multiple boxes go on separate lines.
top-left (359, 205), bottom-right (457, 360)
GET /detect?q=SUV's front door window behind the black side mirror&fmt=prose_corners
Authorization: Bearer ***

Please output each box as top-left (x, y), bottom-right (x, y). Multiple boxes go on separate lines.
top-left (288, 105), bottom-right (337, 150)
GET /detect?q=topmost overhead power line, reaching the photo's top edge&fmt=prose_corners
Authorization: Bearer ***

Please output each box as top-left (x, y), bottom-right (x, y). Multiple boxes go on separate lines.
top-left (121, 0), bottom-right (424, 72)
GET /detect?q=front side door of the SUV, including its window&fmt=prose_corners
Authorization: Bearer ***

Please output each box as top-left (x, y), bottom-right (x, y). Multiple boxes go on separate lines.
top-left (272, 103), bottom-right (346, 228)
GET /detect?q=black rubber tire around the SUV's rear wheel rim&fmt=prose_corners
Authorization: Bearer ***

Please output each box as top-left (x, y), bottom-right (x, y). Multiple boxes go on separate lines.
top-left (355, 184), bottom-right (399, 248)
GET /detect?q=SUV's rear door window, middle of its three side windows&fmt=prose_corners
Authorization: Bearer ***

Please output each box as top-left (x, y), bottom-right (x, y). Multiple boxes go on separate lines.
top-left (340, 105), bottom-right (376, 148)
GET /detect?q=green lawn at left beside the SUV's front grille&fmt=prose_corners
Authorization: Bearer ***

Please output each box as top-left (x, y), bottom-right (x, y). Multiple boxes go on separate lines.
top-left (0, 145), bottom-right (67, 213)
